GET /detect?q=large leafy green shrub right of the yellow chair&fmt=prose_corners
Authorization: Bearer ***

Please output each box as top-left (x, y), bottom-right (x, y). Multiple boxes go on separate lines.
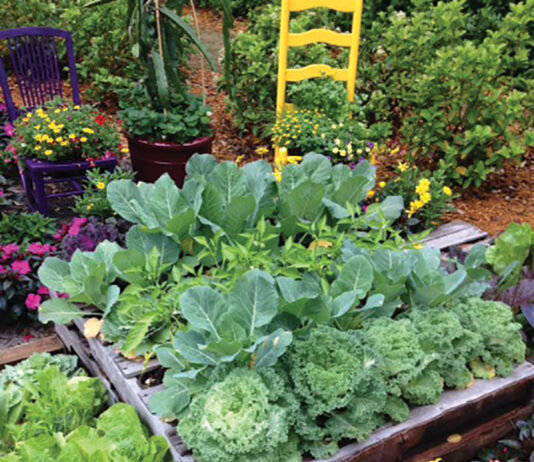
top-left (360, 0), bottom-right (534, 186)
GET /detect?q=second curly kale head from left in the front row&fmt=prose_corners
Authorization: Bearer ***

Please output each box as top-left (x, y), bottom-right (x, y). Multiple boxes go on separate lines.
top-left (285, 326), bottom-right (387, 459)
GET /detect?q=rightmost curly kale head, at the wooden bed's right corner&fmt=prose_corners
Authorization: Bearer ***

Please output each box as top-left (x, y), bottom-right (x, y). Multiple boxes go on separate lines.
top-left (452, 298), bottom-right (526, 378)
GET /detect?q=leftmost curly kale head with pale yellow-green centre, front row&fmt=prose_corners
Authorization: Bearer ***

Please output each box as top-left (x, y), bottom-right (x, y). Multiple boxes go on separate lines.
top-left (178, 368), bottom-right (302, 462)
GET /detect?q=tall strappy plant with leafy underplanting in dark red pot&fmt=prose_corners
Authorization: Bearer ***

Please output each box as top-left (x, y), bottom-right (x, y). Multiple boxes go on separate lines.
top-left (90, 0), bottom-right (215, 186)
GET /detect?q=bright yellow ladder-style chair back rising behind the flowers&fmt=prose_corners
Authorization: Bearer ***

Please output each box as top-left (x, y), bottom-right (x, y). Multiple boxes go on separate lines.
top-left (276, 0), bottom-right (363, 117)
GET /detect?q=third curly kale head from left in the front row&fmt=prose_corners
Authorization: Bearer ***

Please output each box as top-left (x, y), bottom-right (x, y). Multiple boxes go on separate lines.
top-left (364, 318), bottom-right (443, 405)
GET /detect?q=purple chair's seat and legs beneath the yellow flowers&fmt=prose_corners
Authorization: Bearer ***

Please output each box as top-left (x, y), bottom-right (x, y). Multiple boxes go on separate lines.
top-left (21, 157), bottom-right (117, 215)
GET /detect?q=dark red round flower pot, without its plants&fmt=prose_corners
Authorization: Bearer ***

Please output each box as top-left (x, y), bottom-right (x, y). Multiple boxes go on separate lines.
top-left (125, 133), bottom-right (213, 187)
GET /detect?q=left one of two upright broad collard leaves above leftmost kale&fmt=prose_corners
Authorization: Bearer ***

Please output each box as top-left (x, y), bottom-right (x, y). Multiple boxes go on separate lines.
top-left (180, 286), bottom-right (227, 340)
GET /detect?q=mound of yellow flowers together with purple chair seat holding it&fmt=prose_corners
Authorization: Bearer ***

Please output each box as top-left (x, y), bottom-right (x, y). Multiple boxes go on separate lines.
top-left (7, 100), bottom-right (124, 215)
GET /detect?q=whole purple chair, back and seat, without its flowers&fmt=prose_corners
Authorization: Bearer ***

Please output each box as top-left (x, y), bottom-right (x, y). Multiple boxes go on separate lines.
top-left (0, 27), bottom-right (117, 215)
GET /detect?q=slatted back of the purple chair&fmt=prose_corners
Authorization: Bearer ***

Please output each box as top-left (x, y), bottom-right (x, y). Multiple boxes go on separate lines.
top-left (0, 27), bottom-right (81, 122)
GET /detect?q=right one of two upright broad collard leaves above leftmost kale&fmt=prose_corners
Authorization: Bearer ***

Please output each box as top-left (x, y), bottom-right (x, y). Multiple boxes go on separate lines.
top-left (228, 270), bottom-right (278, 338)
